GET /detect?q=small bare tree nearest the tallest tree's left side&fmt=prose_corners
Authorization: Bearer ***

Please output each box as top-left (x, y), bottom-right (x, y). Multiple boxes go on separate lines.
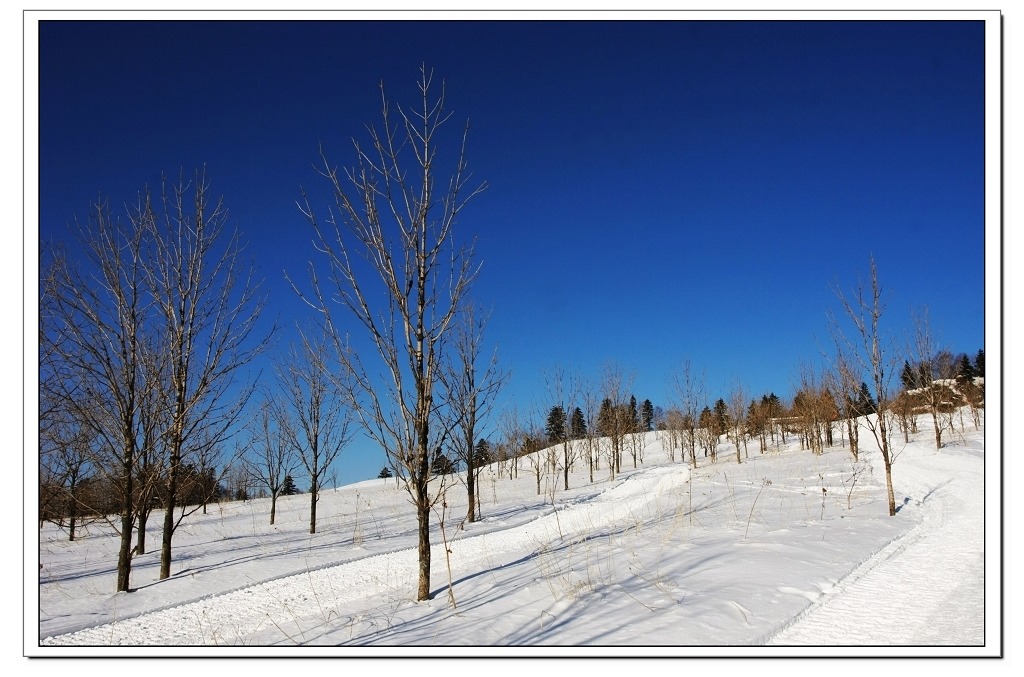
top-left (274, 334), bottom-right (351, 534)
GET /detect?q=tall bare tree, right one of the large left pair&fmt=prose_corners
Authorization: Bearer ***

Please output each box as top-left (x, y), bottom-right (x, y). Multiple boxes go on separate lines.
top-left (144, 171), bottom-right (269, 580)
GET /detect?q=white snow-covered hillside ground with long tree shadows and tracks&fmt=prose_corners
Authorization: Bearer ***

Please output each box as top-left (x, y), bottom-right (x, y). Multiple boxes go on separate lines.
top-left (26, 409), bottom-right (1004, 657)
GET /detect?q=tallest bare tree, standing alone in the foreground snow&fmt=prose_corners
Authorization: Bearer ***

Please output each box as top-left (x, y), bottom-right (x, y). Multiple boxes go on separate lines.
top-left (300, 68), bottom-right (484, 600)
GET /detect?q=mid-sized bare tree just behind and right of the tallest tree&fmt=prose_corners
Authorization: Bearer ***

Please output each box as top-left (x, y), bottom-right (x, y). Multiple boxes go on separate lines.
top-left (439, 305), bottom-right (509, 522)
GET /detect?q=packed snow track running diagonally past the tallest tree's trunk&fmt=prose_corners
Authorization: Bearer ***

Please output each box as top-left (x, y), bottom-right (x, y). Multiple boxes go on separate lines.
top-left (40, 466), bottom-right (689, 646)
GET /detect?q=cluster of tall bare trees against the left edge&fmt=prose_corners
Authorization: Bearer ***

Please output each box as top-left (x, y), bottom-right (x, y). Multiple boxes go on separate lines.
top-left (39, 172), bottom-right (269, 591)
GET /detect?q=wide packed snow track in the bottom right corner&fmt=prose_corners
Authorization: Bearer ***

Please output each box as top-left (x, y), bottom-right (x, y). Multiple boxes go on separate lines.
top-left (765, 450), bottom-right (985, 646)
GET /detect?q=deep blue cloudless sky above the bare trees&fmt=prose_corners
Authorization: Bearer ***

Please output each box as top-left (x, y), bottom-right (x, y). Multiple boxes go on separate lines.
top-left (38, 13), bottom-right (997, 481)
